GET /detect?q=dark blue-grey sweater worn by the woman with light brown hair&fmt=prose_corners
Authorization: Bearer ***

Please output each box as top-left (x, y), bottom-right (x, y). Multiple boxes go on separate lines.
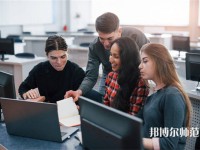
top-left (137, 86), bottom-right (186, 150)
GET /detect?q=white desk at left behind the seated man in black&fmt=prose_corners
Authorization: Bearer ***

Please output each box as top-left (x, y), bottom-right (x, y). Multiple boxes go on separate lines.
top-left (0, 55), bottom-right (46, 96)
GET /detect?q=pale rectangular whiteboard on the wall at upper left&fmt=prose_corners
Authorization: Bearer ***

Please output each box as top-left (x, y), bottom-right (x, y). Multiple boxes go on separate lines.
top-left (0, 0), bottom-right (53, 25)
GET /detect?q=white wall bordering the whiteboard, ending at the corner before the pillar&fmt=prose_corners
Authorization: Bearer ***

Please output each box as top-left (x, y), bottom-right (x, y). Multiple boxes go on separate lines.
top-left (0, 0), bottom-right (70, 37)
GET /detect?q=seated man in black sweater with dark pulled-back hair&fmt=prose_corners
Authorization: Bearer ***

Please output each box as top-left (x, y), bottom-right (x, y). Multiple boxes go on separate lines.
top-left (19, 35), bottom-right (85, 103)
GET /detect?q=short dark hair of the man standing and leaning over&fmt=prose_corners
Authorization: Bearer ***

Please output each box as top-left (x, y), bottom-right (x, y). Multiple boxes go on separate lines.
top-left (95, 12), bottom-right (119, 33)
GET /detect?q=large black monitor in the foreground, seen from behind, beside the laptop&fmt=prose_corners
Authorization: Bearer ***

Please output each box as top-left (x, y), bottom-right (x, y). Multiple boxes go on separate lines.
top-left (79, 96), bottom-right (143, 150)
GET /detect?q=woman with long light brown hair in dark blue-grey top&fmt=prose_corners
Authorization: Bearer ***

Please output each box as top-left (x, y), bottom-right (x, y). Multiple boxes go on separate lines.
top-left (138, 43), bottom-right (191, 150)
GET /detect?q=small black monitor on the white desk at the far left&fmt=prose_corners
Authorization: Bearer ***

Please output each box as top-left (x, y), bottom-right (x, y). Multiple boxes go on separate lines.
top-left (0, 38), bottom-right (15, 61)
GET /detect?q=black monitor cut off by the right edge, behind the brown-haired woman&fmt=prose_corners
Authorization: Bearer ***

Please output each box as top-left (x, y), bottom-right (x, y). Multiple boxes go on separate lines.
top-left (185, 53), bottom-right (200, 90)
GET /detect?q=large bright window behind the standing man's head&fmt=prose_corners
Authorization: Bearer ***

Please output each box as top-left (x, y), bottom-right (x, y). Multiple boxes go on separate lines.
top-left (91, 0), bottom-right (189, 26)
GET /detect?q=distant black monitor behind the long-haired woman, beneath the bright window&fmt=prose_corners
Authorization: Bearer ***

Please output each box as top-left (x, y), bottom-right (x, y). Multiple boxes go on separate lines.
top-left (172, 35), bottom-right (190, 58)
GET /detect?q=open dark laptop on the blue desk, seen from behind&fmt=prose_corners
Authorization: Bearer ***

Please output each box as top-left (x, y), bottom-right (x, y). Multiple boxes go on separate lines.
top-left (0, 98), bottom-right (78, 142)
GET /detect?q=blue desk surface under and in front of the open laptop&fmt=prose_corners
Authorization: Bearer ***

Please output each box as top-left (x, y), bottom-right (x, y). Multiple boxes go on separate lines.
top-left (0, 123), bottom-right (83, 150)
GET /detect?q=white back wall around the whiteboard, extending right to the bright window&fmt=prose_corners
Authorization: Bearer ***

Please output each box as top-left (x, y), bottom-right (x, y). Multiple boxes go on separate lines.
top-left (0, 0), bottom-right (94, 37)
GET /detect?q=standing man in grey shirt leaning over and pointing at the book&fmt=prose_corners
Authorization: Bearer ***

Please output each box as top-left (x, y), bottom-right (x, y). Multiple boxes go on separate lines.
top-left (65, 12), bottom-right (149, 101)
